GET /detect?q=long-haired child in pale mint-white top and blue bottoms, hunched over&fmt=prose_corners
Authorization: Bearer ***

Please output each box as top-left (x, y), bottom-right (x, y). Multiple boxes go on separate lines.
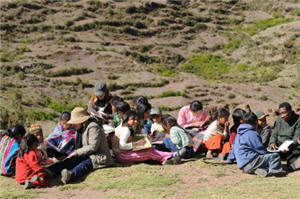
top-left (162, 114), bottom-right (195, 158)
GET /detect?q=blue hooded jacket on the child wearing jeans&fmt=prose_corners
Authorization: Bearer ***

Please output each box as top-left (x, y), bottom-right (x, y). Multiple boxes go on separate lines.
top-left (227, 124), bottom-right (267, 169)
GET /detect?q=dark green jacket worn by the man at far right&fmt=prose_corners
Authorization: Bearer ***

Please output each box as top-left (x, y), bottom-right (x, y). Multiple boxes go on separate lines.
top-left (269, 112), bottom-right (300, 146)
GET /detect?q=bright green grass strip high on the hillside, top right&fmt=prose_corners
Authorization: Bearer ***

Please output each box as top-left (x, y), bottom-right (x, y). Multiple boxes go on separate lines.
top-left (242, 15), bottom-right (294, 36)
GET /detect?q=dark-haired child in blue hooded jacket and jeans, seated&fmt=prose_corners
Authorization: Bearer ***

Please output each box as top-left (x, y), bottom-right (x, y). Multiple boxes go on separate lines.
top-left (226, 112), bottom-right (286, 177)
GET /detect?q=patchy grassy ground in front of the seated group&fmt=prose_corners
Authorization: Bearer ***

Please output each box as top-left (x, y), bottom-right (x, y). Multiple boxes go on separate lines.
top-left (0, 159), bottom-right (300, 198)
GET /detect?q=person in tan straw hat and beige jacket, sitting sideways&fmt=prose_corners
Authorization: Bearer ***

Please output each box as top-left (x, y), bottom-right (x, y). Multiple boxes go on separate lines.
top-left (48, 107), bottom-right (113, 184)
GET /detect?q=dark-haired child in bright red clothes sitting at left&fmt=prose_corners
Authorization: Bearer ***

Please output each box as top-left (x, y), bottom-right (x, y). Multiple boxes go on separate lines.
top-left (16, 134), bottom-right (48, 189)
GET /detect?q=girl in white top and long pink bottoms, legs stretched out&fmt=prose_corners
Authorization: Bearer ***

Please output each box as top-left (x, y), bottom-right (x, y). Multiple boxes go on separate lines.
top-left (112, 111), bottom-right (180, 164)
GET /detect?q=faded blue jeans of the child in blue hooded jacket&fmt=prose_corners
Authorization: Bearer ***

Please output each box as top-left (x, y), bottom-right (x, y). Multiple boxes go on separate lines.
top-left (243, 153), bottom-right (282, 173)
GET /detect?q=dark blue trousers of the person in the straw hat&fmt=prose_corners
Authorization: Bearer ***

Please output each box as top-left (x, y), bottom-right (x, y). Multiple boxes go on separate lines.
top-left (48, 156), bottom-right (93, 180)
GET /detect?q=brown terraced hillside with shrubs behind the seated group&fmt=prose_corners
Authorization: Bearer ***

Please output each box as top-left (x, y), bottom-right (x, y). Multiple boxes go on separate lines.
top-left (0, 0), bottom-right (300, 132)
